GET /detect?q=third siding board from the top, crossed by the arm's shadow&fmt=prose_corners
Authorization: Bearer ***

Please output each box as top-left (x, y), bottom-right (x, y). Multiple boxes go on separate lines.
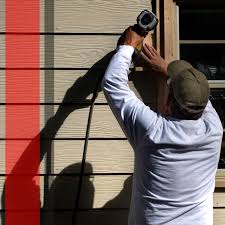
top-left (0, 70), bottom-right (157, 105)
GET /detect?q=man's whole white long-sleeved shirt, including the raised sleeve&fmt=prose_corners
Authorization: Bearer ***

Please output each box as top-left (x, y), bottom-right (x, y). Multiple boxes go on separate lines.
top-left (102, 37), bottom-right (223, 225)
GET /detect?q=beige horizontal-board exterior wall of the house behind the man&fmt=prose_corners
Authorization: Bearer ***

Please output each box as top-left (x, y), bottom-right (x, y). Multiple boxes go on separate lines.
top-left (0, 0), bottom-right (225, 225)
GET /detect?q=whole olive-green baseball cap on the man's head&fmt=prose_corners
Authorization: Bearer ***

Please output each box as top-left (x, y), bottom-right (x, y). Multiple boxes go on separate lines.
top-left (167, 60), bottom-right (209, 115)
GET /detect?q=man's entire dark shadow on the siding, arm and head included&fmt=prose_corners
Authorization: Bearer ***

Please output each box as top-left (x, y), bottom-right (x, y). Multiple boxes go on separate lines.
top-left (1, 52), bottom-right (138, 225)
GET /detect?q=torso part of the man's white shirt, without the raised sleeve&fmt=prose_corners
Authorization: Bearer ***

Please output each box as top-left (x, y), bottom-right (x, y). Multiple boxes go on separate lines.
top-left (129, 102), bottom-right (222, 225)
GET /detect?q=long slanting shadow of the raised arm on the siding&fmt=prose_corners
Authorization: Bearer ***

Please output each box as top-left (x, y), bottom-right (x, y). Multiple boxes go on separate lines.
top-left (1, 52), bottom-right (114, 225)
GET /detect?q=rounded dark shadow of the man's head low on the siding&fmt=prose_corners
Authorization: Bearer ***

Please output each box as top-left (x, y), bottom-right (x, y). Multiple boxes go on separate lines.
top-left (41, 163), bottom-right (95, 225)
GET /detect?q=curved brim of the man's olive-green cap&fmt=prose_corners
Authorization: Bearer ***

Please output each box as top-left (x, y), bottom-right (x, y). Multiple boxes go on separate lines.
top-left (167, 60), bottom-right (193, 79)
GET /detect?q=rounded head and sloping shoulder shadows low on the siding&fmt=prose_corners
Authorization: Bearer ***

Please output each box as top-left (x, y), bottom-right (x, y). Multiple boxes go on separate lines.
top-left (44, 162), bottom-right (132, 225)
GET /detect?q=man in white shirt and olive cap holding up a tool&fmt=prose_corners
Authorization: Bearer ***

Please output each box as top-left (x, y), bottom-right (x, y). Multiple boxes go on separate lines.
top-left (102, 28), bottom-right (223, 225)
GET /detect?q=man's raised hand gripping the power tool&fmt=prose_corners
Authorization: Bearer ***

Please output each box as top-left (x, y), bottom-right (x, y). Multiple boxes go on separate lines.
top-left (117, 27), bottom-right (144, 48)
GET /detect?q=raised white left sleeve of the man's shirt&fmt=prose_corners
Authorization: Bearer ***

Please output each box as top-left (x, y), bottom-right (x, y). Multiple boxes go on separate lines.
top-left (102, 45), bottom-right (159, 147)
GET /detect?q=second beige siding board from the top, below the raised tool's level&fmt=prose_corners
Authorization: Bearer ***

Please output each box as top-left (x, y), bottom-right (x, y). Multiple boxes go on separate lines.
top-left (0, 35), bottom-right (119, 68)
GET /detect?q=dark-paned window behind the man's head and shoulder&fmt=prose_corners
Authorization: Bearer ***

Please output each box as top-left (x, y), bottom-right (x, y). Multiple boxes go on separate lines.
top-left (179, 0), bottom-right (225, 168)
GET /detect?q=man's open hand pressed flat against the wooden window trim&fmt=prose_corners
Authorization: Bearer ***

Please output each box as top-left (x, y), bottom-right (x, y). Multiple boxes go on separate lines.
top-left (142, 44), bottom-right (168, 77)
